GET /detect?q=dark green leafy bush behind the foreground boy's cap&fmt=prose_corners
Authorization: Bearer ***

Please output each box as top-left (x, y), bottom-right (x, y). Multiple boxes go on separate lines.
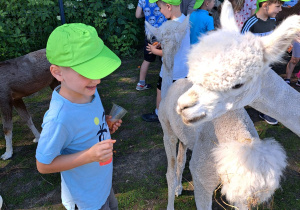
top-left (0, 0), bottom-right (144, 61)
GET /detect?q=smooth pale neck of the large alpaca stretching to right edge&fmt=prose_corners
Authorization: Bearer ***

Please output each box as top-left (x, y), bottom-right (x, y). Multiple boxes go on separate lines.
top-left (250, 70), bottom-right (300, 136)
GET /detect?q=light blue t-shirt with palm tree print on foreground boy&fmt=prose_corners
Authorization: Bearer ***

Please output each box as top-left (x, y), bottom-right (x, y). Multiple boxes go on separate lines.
top-left (36, 86), bottom-right (113, 210)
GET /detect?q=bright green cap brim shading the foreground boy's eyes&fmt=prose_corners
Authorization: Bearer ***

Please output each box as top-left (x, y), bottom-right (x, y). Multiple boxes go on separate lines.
top-left (70, 45), bottom-right (121, 79)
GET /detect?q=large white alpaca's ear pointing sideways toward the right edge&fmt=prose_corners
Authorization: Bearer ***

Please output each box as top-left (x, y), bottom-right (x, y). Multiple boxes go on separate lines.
top-left (260, 15), bottom-right (300, 63)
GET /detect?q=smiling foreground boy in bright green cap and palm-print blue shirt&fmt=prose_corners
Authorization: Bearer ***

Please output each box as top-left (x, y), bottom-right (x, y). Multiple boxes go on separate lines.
top-left (36, 23), bottom-right (122, 209)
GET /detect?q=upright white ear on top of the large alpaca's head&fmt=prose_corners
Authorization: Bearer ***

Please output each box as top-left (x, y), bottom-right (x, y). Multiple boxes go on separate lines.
top-left (220, 0), bottom-right (240, 32)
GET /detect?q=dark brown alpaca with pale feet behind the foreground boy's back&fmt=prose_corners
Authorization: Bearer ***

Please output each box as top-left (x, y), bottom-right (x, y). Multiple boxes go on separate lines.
top-left (0, 49), bottom-right (59, 160)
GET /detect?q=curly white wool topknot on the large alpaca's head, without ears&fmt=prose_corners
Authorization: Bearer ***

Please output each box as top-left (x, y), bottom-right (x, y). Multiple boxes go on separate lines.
top-left (188, 30), bottom-right (264, 91)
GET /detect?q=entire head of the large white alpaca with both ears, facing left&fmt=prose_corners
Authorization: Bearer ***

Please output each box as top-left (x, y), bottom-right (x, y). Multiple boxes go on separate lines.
top-left (177, 0), bottom-right (300, 125)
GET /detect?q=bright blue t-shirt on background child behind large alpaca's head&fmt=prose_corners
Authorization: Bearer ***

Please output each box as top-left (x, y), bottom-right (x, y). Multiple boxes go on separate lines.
top-left (190, 9), bottom-right (215, 45)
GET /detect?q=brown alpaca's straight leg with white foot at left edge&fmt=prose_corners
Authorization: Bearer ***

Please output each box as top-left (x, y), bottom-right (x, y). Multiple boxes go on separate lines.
top-left (0, 97), bottom-right (13, 160)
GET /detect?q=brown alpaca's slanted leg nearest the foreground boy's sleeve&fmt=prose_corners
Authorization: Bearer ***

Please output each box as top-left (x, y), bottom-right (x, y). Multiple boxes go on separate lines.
top-left (13, 98), bottom-right (40, 142)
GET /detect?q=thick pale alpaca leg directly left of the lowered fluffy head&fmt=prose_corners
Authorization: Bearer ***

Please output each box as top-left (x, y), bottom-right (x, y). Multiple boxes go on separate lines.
top-left (190, 139), bottom-right (219, 210)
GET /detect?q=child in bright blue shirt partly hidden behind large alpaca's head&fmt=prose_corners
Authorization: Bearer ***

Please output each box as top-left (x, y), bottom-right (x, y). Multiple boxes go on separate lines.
top-left (190, 0), bottom-right (215, 45)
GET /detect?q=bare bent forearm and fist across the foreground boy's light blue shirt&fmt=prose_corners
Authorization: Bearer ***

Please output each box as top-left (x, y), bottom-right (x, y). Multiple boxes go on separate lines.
top-left (36, 139), bottom-right (116, 174)
